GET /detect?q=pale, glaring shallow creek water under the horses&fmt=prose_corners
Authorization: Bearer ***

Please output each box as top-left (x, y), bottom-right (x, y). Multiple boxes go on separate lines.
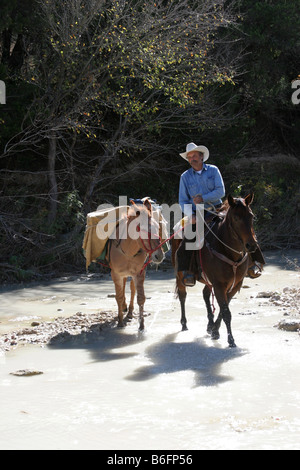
top-left (0, 252), bottom-right (300, 450)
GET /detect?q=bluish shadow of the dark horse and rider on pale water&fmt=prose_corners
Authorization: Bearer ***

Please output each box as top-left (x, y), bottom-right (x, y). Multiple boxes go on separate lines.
top-left (126, 333), bottom-right (246, 387)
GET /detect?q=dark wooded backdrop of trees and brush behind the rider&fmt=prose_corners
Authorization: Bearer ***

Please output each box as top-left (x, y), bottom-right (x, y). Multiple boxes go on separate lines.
top-left (0, 0), bottom-right (300, 278)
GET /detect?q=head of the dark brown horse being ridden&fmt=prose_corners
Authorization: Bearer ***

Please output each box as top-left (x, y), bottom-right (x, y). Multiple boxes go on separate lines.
top-left (226, 193), bottom-right (257, 253)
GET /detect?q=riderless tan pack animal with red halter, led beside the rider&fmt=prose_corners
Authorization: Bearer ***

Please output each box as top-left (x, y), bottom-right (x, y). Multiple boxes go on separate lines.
top-left (106, 200), bottom-right (164, 330)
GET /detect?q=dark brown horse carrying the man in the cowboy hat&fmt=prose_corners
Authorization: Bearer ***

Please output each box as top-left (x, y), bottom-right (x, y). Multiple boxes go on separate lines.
top-left (172, 193), bottom-right (257, 347)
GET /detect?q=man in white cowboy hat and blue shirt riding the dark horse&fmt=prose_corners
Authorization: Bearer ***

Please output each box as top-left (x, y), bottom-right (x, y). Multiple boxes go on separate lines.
top-left (177, 142), bottom-right (225, 286)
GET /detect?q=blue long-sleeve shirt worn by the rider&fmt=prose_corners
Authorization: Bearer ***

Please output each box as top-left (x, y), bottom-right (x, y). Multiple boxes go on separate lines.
top-left (179, 163), bottom-right (225, 216)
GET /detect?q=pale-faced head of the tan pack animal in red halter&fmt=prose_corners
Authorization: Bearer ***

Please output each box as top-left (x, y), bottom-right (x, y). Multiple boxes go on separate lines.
top-left (128, 199), bottom-right (164, 264)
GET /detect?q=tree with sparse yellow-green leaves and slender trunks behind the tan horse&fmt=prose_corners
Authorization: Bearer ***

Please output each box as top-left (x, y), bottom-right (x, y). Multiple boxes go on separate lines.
top-left (1, 0), bottom-right (238, 218)
